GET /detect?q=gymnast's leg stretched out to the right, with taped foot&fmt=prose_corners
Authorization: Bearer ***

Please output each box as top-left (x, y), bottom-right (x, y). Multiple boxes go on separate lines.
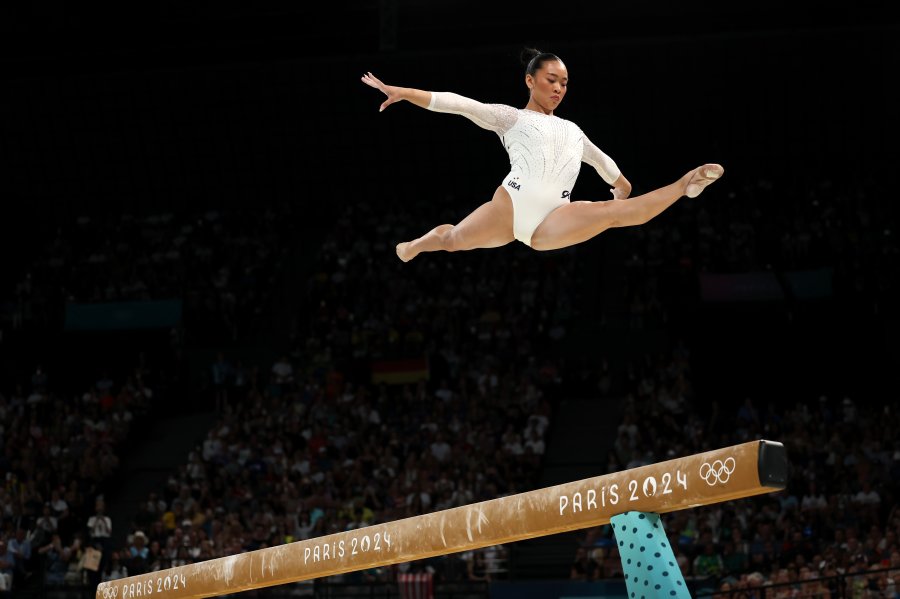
top-left (531, 164), bottom-right (725, 250)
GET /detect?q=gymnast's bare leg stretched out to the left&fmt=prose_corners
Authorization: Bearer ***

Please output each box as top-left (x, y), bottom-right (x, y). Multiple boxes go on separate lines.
top-left (397, 187), bottom-right (515, 262)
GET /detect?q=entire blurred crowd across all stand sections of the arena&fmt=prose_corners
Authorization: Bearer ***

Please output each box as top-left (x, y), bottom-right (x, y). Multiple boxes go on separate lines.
top-left (0, 163), bottom-right (900, 597)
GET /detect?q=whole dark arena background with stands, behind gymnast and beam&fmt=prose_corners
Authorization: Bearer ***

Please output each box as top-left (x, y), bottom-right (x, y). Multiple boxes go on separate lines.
top-left (0, 0), bottom-right (900, 599)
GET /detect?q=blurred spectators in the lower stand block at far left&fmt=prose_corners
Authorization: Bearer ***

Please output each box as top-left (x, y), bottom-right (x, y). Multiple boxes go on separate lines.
top-left (0, 360), bottom-right (154, 591)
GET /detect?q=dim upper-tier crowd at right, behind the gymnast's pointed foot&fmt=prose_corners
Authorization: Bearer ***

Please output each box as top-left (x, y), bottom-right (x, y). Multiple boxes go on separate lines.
top-left (623, 173), bottom-right (900, 322)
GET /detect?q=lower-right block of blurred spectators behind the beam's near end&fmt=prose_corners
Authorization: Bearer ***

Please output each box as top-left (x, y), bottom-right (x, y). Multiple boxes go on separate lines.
top-left (571, 351), bottom-right (900, 597)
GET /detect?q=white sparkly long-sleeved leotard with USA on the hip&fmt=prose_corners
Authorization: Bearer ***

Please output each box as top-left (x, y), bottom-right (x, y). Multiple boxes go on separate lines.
top-left (428, 92), bottom-right (621, 246)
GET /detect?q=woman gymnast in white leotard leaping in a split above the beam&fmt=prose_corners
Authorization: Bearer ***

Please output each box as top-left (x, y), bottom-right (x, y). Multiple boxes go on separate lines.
top-left (362, 49), bottom-right (725, 262)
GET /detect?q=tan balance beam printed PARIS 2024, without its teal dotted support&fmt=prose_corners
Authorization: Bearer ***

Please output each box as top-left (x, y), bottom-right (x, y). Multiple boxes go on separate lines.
top-left (96, 440), bottom-right (787, 599)
